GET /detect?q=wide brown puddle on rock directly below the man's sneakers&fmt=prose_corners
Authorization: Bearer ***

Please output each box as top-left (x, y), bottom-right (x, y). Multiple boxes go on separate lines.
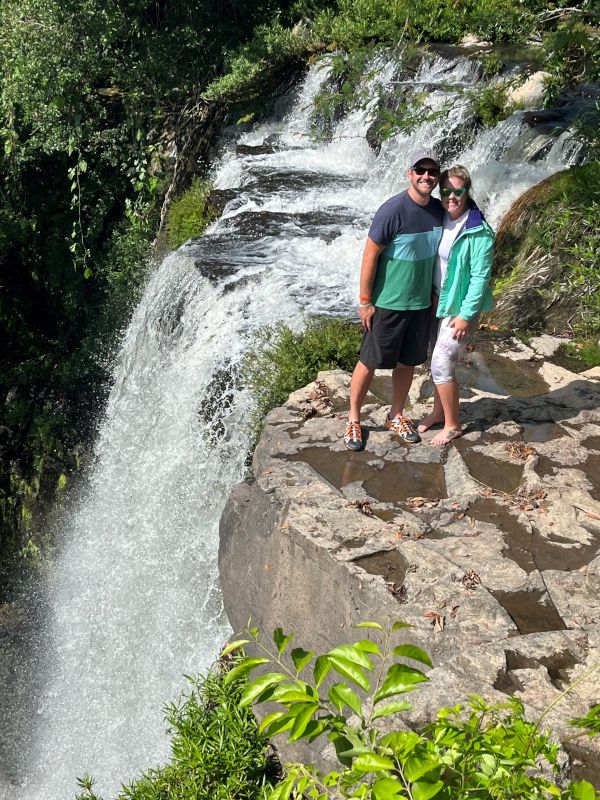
top-left (288, 447), bottom-right (446, 500)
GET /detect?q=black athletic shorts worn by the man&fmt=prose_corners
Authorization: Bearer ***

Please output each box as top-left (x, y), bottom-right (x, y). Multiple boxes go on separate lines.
top-left (360, 307), bottom-right (431, 369)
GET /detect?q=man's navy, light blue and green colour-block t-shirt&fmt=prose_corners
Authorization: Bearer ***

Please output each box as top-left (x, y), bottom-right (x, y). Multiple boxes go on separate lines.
top-left (369, 191), bottom-right (444, 311)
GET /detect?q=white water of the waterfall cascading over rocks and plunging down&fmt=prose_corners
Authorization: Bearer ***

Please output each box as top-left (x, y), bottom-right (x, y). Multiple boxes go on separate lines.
top-left (0, 45), bottom-right (576, 800)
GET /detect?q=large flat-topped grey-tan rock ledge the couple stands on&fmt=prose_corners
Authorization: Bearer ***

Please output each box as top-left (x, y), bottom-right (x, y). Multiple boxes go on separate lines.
top-left (219, 339), bottom-right (600, 782)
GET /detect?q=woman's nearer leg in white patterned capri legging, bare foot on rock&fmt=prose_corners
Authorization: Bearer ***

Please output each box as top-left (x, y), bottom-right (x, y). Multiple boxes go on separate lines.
top-left (431, 317), bottom-right (462, 445)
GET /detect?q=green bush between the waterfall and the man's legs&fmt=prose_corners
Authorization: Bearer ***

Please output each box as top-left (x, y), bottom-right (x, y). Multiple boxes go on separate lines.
top-left (241, 319), bottom-right (361, 436)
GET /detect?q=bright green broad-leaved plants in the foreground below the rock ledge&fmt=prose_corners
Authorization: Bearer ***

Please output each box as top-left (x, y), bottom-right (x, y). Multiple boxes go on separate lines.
top-left (228, 622), bottom-right (600, 800)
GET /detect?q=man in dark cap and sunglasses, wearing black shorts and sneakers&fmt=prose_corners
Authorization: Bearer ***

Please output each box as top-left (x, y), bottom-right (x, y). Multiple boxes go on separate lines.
top-left (344, 150), bottom-right (443, 450)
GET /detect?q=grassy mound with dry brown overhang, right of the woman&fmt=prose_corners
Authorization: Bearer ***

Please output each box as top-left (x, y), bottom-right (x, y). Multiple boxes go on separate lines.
top-left (494, 161), bottom-right (600, 354)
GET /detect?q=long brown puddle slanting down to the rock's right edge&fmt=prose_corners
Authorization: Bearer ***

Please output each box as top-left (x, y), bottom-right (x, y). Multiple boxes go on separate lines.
top-left (468, 499), bottom-right (600, 573)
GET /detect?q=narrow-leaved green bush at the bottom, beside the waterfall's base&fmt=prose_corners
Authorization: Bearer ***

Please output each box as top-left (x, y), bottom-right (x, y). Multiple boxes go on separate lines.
top-left (73, 667), bottom-right (275, 800)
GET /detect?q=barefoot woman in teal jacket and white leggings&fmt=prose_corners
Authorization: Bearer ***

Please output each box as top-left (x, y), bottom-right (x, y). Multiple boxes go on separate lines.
top-left (418, 165), bottom-right (494, 445)
